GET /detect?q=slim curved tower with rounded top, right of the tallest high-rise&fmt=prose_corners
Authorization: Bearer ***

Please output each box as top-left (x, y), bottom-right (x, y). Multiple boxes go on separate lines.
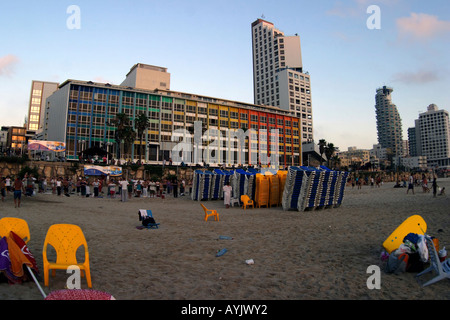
top-left (375, 86), bottom-right (403, 156)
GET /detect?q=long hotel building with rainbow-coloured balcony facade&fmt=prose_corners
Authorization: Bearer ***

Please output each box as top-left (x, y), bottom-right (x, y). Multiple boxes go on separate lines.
top-left (41, 64), bottom-right (302, 166)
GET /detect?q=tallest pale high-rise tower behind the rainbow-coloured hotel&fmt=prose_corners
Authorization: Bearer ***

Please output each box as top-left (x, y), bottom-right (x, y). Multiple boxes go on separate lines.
top-left (252, 19), bottom-right (314, 142)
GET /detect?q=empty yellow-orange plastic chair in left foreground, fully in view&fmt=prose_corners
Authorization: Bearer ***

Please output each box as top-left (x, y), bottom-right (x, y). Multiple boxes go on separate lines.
top-left (42, 224), bottom-right (92, 288)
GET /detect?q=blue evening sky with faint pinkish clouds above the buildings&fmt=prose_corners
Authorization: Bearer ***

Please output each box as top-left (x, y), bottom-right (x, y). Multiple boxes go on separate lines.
top-left (0, 0), bottom-right (450, 151)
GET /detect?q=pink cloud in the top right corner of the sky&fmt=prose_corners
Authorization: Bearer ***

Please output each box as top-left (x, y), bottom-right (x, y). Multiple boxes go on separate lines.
top-left (396, 12), bottom-right (450, 40)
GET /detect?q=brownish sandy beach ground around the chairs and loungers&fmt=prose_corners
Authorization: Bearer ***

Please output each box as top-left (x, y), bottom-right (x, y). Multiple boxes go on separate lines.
top-left (0, 178), bottom-right (450, 300)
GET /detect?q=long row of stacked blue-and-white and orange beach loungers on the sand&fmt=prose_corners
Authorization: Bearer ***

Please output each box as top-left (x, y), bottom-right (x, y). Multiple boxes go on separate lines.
top-left (191, 166), bottom-right (348, 211)
